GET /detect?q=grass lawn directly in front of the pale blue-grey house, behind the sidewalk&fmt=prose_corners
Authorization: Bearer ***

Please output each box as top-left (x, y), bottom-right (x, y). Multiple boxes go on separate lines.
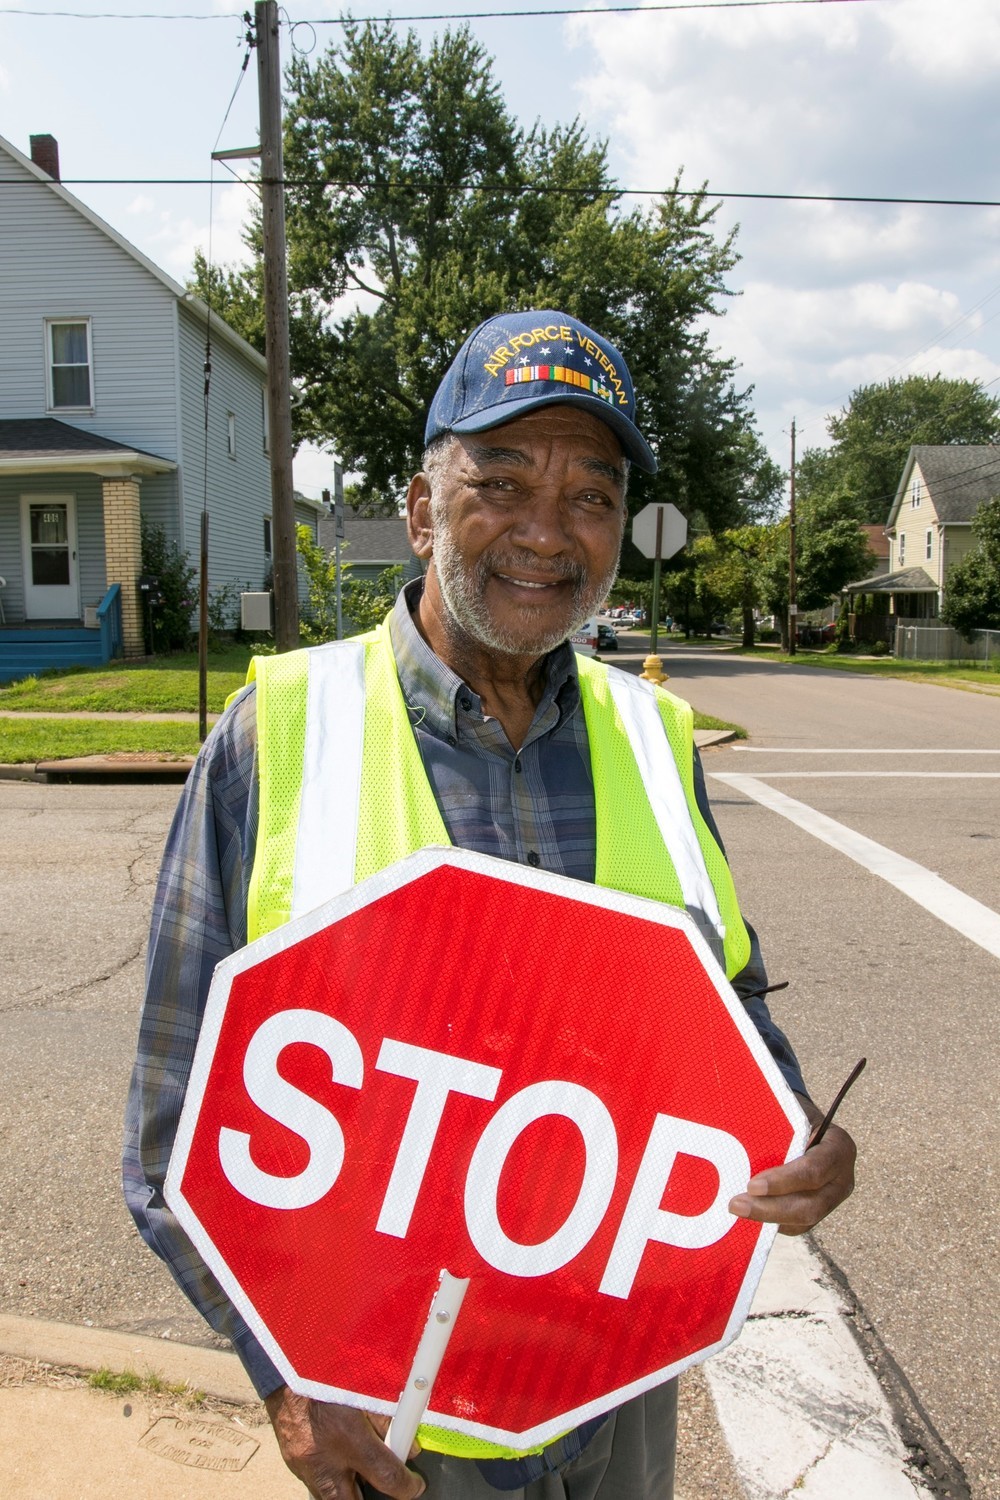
top-left (0, 647), bottom-right (253, 714)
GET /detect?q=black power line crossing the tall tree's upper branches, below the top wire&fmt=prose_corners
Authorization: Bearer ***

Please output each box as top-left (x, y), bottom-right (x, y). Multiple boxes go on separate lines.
top-left (0, 177), bottom-right (1000, 209)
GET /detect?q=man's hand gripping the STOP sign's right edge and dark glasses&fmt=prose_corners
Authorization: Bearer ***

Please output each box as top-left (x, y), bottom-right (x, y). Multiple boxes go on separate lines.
top-left (729, 1095), bottom-right (858, 1235)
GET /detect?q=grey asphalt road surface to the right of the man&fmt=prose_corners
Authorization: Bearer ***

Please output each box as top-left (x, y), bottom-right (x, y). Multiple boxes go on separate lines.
top-left (644, 648), bottom-right (1000, 1500)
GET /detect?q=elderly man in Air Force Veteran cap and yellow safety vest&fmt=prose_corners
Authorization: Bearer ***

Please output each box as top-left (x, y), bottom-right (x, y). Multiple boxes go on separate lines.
top-left (124, 311), bottom-right (855, 1500)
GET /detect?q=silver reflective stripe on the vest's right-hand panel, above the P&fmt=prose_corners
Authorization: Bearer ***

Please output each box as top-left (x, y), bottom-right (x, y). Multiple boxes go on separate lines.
top-left (607, 668), bottom-right (726, 947)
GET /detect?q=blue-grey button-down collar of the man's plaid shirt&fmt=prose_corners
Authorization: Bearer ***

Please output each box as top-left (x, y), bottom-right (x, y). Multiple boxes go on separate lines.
top-left (388, 578), bottom-right (580, 740)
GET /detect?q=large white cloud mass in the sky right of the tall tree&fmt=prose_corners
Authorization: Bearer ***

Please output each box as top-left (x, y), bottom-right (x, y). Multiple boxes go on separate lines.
top-left (567, 0), bottom-right (1000, 458)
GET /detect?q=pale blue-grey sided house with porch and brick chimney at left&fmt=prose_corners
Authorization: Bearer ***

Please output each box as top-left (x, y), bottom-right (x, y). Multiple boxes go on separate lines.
top-left (0, 137), bottom-right (319, 680)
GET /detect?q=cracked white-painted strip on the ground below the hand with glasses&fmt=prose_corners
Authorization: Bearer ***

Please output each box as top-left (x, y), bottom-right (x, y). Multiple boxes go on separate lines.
top-left (703, 1235), bottom-right (928, 1500)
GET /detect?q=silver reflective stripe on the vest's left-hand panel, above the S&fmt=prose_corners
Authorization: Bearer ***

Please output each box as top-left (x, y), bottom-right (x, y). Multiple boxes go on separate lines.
top-left (292, 641), bottom-right (364, 917)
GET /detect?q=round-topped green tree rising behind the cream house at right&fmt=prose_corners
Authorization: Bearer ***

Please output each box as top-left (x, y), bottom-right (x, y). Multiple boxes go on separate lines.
top-left (796, 375), bottom-right (1000, 522)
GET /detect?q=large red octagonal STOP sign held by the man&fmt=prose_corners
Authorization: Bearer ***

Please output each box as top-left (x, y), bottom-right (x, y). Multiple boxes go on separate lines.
top-left (166, 849), bottom-right (807, 1448)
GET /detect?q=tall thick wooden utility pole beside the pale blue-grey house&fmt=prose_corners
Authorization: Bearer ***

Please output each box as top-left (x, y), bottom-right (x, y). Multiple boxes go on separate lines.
top-left (253, 0), bottom-right (298, 651)
